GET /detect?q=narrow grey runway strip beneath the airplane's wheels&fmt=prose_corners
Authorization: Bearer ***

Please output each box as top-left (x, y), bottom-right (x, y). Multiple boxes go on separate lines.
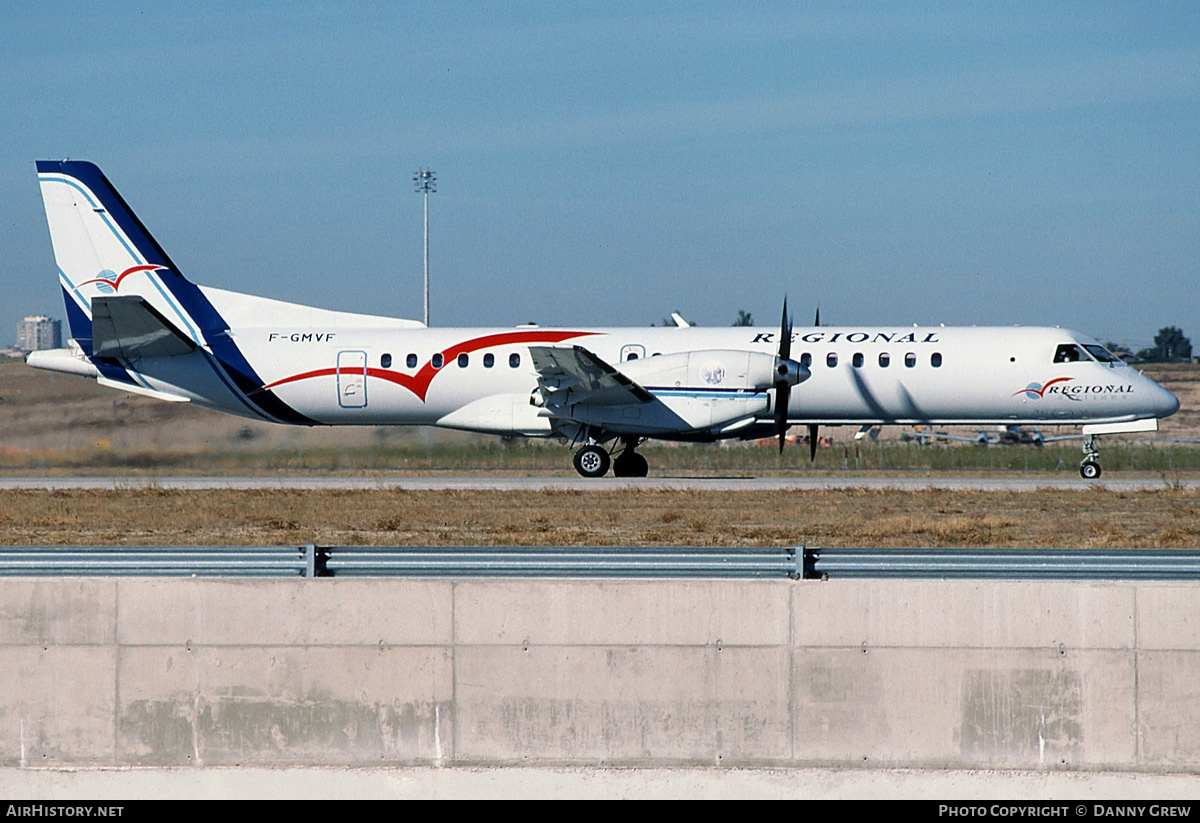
top-left (0, 474), bottom-right (1200, 492)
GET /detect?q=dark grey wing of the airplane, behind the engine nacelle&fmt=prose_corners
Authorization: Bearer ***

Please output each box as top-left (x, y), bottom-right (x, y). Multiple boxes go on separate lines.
top-left (529, 346), bottom-right (654, 408)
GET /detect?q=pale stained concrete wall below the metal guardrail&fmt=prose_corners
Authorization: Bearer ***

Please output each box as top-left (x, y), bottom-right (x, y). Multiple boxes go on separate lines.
top-left (0, 579), bottom-right (1200, 771)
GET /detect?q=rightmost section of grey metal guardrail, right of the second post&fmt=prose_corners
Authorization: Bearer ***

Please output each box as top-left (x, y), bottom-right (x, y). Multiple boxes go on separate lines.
top-left (804, 548), bottom-right (1200, 581)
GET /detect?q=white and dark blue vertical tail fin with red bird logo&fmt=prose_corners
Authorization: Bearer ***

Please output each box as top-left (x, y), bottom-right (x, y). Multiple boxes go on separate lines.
top-left (37, 161), bottom-right (208, 355)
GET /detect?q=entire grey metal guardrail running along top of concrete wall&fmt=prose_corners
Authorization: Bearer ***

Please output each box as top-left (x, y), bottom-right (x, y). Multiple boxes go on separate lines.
top-left (0, 543), bottom-right (1200, 581)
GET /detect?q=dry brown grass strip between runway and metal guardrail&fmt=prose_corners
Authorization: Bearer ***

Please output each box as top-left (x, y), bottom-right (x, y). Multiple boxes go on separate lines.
top-left (0, 488), bottom-right (1200, 548)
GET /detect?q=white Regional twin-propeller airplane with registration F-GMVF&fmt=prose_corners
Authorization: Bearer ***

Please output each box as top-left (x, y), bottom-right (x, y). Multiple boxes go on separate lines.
top-left (28, 161), bottom-right (1180, 479)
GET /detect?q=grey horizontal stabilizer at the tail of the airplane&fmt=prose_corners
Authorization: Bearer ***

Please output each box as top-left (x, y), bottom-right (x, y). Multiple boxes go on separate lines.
top-left (91, 295), bottom-right (196, 360)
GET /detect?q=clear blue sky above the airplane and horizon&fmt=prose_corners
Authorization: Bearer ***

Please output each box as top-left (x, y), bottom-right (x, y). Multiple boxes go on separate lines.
top-left (0, 1), bottom-right (1200, 347)
